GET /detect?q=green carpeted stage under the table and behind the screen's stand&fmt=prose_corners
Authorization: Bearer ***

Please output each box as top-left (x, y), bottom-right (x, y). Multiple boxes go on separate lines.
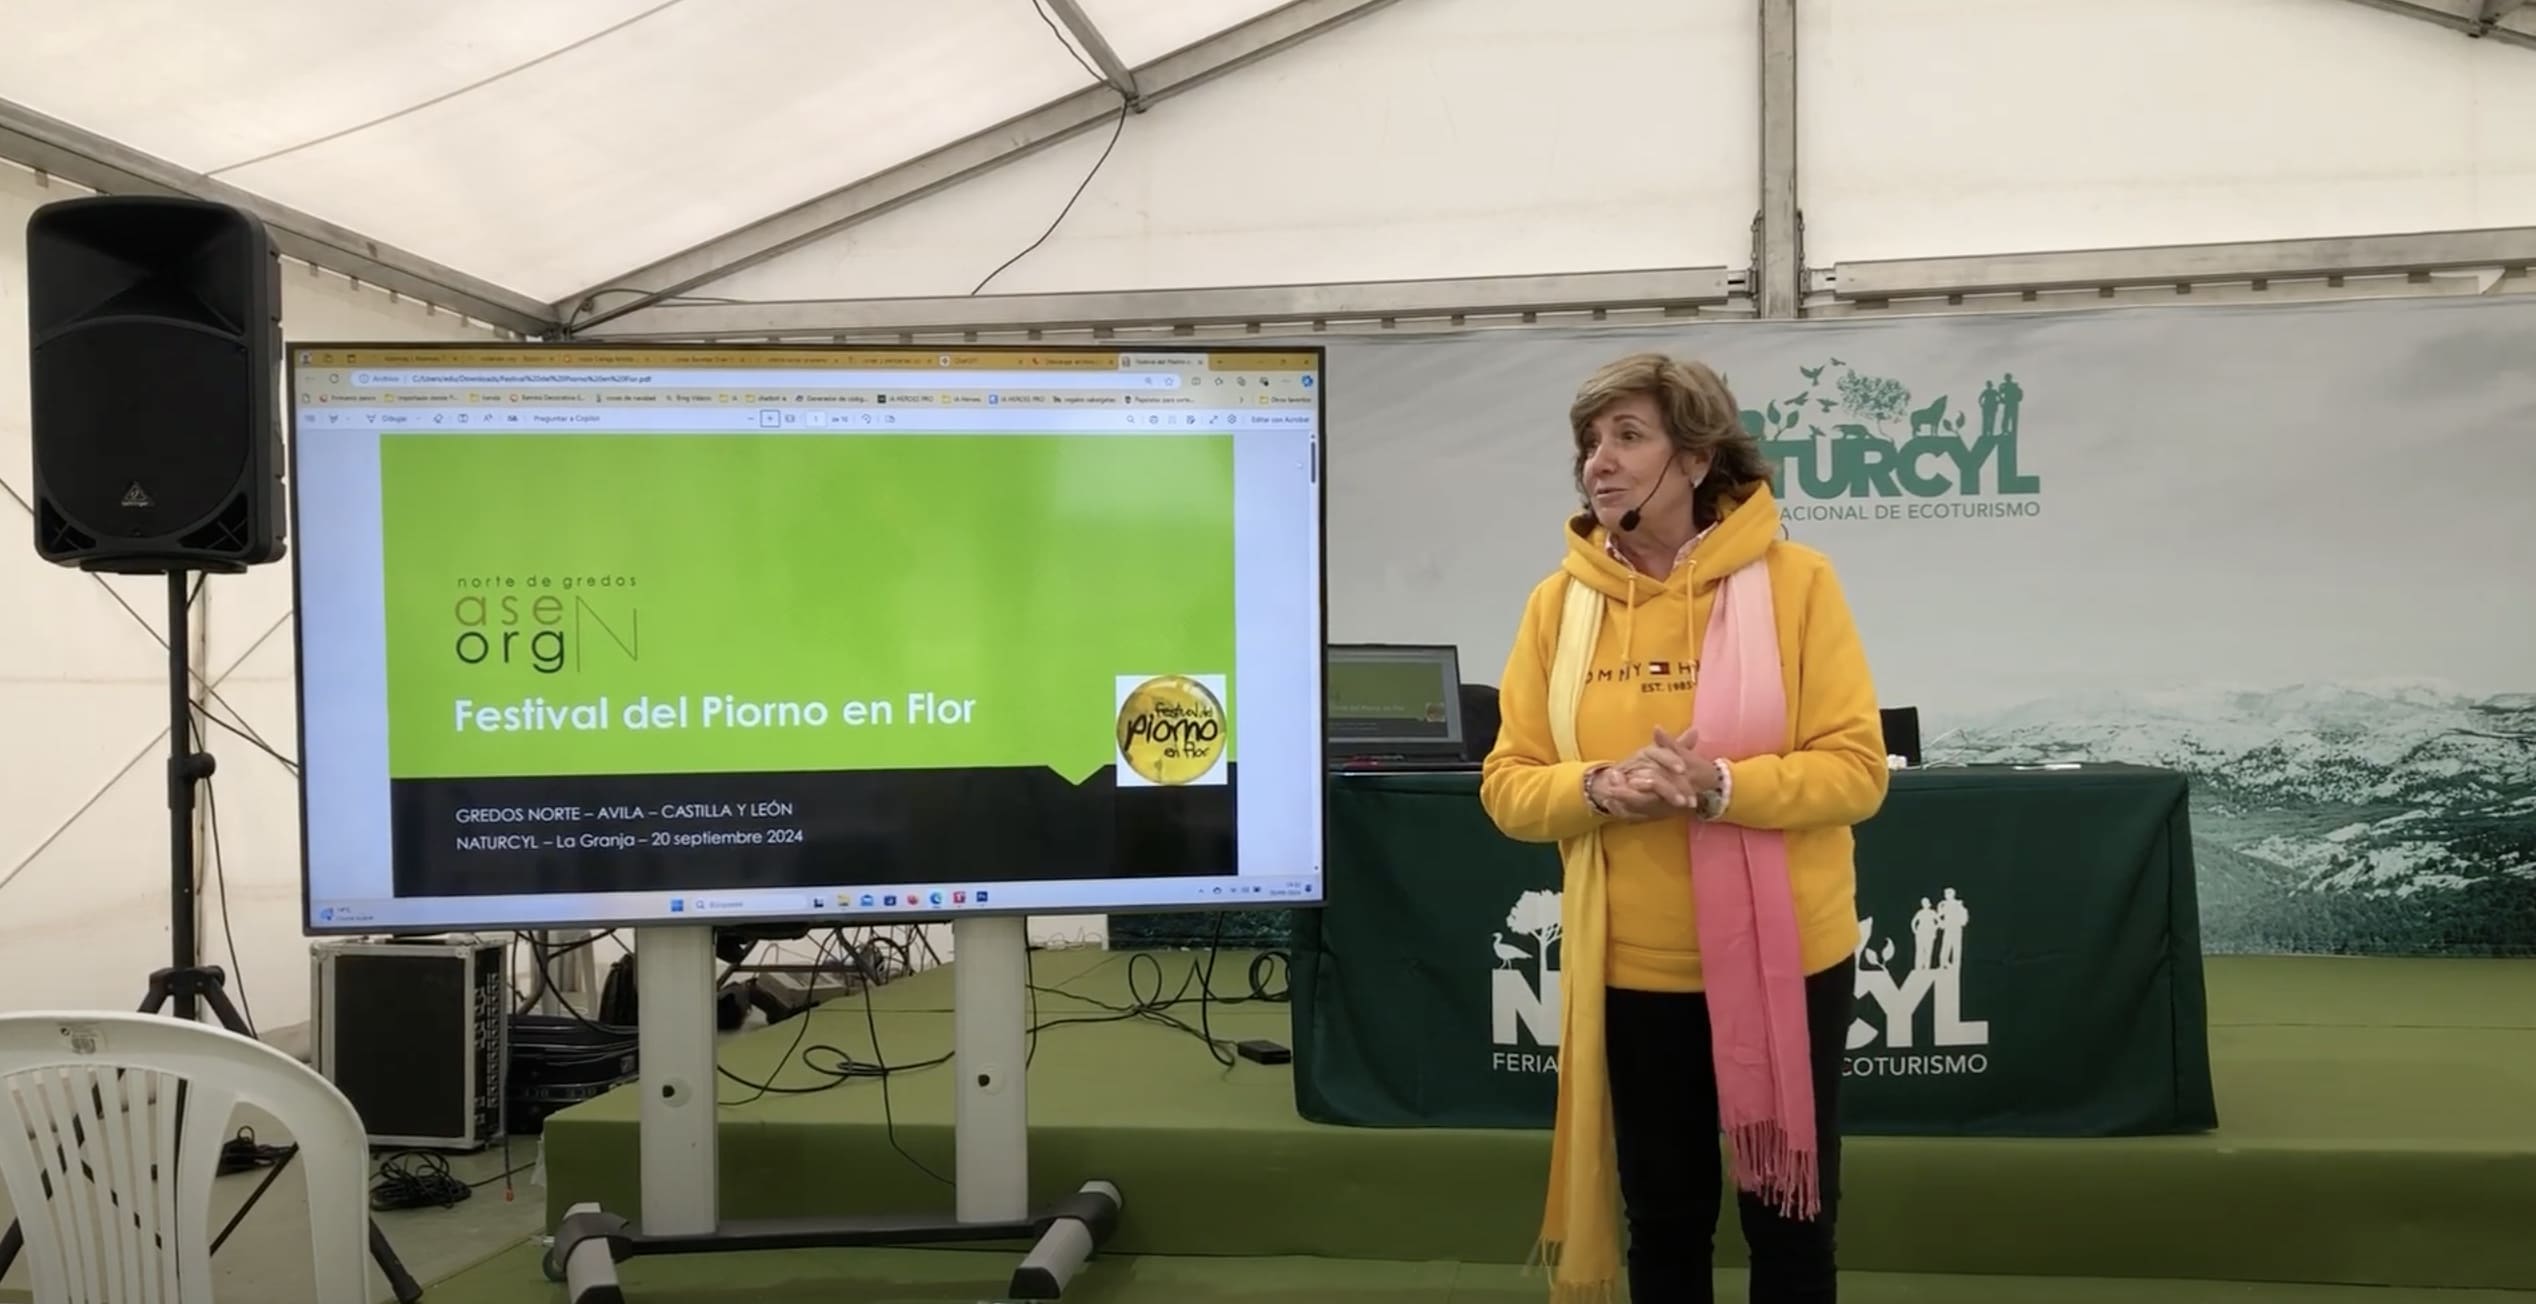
top-left (434, 951), bottom-right (2536, 1304)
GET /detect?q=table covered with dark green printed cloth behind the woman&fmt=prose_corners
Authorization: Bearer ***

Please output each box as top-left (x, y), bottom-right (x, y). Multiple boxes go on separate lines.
top-left (1291, 766), bottom-right (2216, 1137)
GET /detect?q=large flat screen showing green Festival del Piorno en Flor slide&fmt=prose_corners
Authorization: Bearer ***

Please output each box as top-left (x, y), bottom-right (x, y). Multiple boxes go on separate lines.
top-left (289, 345), bottom-right (1324, 934)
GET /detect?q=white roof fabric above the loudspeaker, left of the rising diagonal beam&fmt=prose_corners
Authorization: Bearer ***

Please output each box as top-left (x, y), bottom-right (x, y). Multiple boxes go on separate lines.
top-left (0, 0), bottom-right (1364, 324)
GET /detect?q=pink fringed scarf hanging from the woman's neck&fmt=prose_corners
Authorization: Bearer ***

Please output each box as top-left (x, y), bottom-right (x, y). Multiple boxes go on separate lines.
top-left (1692, 561), bottom-right (1821, 1218)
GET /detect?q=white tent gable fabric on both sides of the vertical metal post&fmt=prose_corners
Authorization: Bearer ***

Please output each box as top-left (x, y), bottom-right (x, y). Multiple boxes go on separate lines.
top-left (598, 0), bottom-right (2536, 327)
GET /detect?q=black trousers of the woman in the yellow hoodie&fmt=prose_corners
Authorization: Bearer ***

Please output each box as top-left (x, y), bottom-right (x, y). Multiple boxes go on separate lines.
top-left (1605, 962), bottom-right (1856, 1304)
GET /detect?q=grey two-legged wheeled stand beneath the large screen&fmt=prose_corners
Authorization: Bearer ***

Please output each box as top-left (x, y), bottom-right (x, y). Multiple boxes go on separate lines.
top-left (545, 916), bottom-right (1121, 1304)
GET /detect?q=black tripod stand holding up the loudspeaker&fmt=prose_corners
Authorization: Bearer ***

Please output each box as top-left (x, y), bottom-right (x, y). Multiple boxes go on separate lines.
top-left (0, 568), bottom-right (424, 1304)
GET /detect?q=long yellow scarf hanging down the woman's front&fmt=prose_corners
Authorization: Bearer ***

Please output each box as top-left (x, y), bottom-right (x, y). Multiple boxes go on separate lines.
top-left (1539, 581), bottom-right (1621, 1304)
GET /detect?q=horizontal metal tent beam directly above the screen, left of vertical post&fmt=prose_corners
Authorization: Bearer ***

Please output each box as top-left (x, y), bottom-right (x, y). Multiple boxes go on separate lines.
top-left (576, 266), bottom-right (1740, 340)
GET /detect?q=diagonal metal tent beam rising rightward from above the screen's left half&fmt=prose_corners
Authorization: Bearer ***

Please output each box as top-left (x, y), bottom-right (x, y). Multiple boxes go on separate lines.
top-left (553, 0), bottom-right (1392, 332)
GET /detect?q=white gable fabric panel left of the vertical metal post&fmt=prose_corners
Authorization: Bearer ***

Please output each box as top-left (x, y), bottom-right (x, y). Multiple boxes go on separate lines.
top-left (644, 0), bottom-right (1760, 299)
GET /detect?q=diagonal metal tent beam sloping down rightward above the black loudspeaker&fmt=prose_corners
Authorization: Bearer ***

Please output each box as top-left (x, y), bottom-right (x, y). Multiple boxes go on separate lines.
top-left (0, 99), bottom-right (555, 335)
